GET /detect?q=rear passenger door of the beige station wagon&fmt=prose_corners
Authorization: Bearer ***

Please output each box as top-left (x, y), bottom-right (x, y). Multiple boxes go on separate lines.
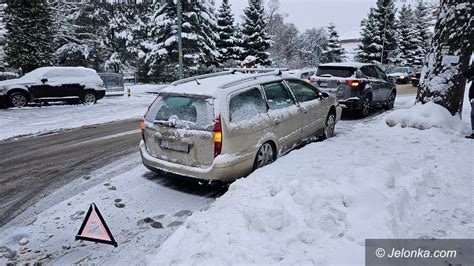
top-left (262, 81), bottom-right (303, 153)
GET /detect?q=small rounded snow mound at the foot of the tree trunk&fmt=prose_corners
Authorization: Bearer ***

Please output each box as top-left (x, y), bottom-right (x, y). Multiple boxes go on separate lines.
top-left (385, 102), bottom-right (465, 131)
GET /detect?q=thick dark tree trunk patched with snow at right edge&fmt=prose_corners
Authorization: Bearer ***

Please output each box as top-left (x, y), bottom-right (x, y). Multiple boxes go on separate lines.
top-left (416, 0), bottom-right (474, 115)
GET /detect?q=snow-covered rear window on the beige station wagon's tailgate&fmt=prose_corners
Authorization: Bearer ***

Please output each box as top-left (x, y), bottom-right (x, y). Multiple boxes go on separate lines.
top-left (145, 95), bottom-right (215, 131)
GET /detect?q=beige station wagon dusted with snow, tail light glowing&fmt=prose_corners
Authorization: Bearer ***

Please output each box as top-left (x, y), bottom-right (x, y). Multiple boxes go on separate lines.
top-left (140, 71), bottom-right (342, 181)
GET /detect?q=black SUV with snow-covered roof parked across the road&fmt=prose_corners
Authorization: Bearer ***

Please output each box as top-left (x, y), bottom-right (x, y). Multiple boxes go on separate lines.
top-left (0, 67), bottom-right (105, 107)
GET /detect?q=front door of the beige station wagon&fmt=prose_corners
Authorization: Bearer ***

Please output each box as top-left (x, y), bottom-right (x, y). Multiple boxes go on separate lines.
top-left (286, 80), bottom-right (325, 139)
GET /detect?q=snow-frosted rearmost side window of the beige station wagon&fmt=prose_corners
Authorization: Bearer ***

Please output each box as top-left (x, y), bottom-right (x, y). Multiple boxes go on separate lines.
top-left (229, 88), bottom-right (267, 122)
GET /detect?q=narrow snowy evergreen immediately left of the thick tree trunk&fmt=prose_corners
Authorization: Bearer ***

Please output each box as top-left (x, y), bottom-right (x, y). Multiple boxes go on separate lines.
top-left (411, 0), bottom-right (433, 67)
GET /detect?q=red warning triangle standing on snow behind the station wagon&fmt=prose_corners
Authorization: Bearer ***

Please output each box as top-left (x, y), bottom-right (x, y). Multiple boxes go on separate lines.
top-left (76, 203), bottom-right (117, 246)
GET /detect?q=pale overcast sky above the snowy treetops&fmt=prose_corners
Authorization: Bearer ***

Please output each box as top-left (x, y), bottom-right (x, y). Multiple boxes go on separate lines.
top-left (224, 0), bottom-right (428, 38)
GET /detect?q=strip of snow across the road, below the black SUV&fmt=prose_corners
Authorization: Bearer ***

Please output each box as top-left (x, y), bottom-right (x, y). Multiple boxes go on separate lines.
top-left (0, 85), bottom-right (163, 140)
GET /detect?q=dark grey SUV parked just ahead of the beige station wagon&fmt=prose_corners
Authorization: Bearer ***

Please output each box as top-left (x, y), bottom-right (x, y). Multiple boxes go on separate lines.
top-left (311, 63), bottom-right (397, 117)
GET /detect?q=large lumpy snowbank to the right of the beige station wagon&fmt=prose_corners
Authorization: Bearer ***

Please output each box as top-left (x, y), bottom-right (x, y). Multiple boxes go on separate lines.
top-left (150, 101), bottom-right (474, 265)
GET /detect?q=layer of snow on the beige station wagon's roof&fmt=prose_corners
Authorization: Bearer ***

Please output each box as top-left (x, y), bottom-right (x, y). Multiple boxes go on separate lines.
top-left (160, 72), bottom-right (294, 97)
